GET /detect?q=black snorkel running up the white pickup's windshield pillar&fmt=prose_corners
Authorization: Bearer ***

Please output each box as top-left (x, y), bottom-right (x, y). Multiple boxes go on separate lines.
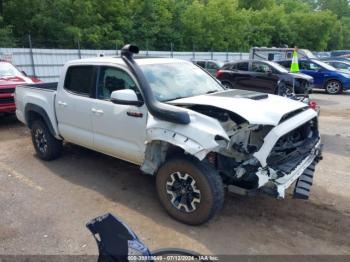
top-left (121, 44), bottom-right (191, 125)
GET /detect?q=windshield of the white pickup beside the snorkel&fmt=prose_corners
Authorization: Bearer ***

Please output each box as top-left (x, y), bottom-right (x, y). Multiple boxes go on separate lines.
top-left (141, 62), bottom-right (224, 102)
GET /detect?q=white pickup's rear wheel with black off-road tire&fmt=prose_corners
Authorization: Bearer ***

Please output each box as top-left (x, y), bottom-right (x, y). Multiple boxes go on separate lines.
top-left (31, 120), bottom-right (62, 161)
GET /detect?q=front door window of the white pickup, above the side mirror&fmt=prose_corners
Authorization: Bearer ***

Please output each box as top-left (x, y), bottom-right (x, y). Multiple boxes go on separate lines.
top-left (97, 66), bottom-right (140, 100)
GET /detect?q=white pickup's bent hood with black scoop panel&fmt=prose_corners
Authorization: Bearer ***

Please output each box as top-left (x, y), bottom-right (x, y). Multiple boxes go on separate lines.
top-left (168, 90), bottom-right (307, 126)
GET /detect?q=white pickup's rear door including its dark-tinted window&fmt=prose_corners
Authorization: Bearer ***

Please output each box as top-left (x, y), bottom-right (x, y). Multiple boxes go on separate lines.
top-left (55, 65), bottom-right (96, 148)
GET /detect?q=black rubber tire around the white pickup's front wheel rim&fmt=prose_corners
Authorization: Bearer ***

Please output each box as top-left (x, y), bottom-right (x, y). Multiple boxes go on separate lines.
top-left (156, 156), bottom-right (225, 225)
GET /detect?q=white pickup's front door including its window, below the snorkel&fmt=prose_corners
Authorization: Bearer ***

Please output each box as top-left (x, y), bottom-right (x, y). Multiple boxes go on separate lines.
top-left (91, 66), bottom-right (147, 164)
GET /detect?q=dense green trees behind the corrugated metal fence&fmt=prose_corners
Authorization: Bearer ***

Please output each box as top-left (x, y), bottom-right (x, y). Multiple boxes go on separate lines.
top-left (0, 0), bottom-right (350, 51)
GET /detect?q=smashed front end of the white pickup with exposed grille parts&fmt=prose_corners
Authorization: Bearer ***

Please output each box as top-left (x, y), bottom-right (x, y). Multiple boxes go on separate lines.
top-left (194, 105), bottom-right (322, 199)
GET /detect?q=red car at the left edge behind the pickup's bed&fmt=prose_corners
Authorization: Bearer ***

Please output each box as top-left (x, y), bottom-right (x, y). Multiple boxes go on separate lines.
top-left (0, 61), bottom-right (40, 113)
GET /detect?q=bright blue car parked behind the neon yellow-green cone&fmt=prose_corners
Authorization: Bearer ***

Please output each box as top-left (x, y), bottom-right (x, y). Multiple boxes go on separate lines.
top-left (278, 59), bottom-right (350, 94)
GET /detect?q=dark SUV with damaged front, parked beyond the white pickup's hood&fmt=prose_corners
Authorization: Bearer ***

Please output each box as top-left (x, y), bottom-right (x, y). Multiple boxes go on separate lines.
top-left (216, 60), bottom-right (313, 94)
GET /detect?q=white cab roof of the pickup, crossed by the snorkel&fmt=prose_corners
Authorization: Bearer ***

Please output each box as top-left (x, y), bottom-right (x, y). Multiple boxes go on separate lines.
top-left (67, 56), bottom-right (186, 65)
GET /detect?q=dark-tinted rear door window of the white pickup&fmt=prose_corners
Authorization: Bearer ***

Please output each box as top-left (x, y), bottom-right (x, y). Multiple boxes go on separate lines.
top-left (64, 66), bottom-right (94, 96)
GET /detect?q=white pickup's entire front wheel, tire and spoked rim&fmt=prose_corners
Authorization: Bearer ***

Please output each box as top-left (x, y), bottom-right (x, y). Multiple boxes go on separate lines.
top-left (156, 157), bottom-right (224, 225)
